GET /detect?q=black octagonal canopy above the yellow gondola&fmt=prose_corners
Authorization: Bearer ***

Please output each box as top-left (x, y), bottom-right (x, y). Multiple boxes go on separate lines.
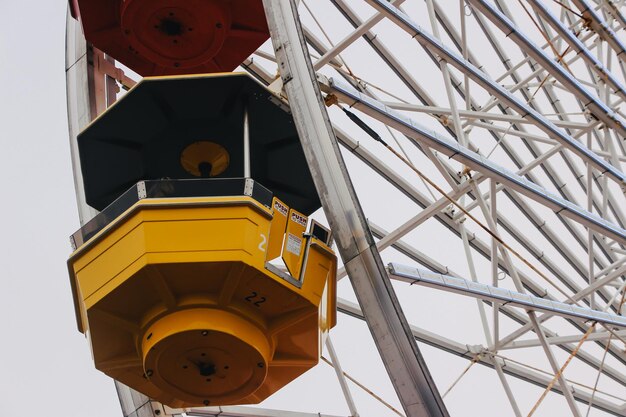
top-left (78, 74), bottom-right (321, 214)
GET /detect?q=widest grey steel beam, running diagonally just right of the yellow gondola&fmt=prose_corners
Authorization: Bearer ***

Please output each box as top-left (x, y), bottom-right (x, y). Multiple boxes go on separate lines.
top-left (263, 0), bottom-right (448, 417)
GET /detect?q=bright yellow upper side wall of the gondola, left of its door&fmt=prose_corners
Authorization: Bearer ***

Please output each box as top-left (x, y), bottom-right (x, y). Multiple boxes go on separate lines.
top-left (70, 197), bottom-right (269, 305)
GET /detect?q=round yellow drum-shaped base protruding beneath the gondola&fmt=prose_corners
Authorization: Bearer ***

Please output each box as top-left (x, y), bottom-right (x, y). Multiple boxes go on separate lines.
top-left (141, 308), bottom-right (272, 405)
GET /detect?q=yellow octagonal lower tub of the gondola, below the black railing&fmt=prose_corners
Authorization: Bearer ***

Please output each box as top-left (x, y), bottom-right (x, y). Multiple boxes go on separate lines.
top-left (68, 198), bottom-right (336, 407)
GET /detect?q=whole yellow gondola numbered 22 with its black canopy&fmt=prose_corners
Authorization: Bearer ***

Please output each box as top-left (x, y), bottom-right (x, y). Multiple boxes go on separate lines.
top-left (68, 71), bottom-right (336, 407)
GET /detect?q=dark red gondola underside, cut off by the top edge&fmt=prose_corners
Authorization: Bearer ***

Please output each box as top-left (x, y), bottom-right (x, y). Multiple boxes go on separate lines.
top-left (70, 0), bottom-right (269, 76)
